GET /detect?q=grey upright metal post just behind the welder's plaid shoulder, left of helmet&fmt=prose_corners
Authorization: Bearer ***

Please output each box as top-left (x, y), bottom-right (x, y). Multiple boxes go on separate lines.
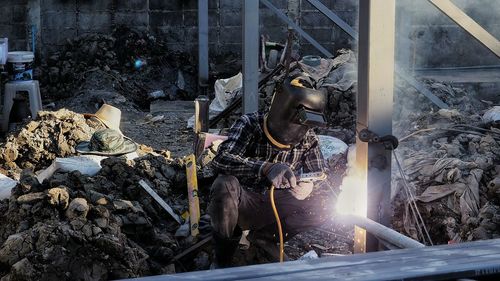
top-left (243, 0), bottom-right (260, 113)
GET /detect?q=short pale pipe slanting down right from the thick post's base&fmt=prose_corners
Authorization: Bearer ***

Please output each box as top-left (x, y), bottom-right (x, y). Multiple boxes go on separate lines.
top-left (342, 215), bottom-right (425, 249)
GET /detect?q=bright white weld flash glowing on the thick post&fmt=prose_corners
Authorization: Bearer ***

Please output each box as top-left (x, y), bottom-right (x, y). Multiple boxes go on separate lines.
top-left (336, 148), bottom-right (368, 217)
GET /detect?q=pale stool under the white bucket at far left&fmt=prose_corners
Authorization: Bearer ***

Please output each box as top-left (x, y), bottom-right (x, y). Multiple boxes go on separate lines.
top-left (2, 80), bottom-right (42, 132)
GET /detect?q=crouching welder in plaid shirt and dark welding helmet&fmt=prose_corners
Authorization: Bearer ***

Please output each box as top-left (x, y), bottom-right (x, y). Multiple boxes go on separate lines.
top-left (208, 74), bottom-right (333, 268)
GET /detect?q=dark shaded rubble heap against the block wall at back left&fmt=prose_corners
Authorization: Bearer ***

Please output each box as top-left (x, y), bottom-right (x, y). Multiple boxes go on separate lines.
top-left (38, 27), bottom-right (197, 107)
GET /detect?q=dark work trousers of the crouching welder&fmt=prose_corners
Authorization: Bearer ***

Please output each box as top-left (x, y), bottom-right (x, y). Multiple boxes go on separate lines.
top-left (208, 175), bottom-right (334, 241)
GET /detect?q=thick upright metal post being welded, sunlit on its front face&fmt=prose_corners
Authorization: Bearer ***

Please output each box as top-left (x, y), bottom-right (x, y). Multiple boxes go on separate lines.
top-left (355, 0), bottom-right (396, 251)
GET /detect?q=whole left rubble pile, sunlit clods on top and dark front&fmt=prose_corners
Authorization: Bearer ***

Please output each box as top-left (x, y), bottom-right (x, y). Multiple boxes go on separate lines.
top-left (0, 109), bottom-right (211, 280)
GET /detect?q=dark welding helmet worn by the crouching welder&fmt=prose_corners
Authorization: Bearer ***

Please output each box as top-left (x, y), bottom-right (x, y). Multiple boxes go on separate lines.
top-left (264, 74), bottom-right (326, 149)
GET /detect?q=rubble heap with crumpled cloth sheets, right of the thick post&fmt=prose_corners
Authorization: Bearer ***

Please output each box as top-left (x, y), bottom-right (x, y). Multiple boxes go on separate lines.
top-left (393, 78), bottom-right (500, 244)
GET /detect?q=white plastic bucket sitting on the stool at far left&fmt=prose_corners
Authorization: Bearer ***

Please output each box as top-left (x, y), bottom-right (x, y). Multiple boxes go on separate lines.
top-left (7, 51), bottom-right (35, 81)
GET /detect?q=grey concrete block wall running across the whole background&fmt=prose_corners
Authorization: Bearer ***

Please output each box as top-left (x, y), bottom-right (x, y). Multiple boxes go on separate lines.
top-left (0, 0), bottom-right (500, 68)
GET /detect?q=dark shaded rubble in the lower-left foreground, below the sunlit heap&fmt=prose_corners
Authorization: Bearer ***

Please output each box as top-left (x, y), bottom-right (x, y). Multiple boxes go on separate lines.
top-left (0, 155), bottom-right (195, 280)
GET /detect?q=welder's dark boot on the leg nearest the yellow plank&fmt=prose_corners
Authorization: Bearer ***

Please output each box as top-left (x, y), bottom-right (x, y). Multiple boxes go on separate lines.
top-left (210, 232), bottom-right (241, 269)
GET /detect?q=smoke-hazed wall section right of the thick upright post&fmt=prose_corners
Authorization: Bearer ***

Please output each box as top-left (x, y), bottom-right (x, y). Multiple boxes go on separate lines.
top-left (396, 0), bottom-right (500, 70)
